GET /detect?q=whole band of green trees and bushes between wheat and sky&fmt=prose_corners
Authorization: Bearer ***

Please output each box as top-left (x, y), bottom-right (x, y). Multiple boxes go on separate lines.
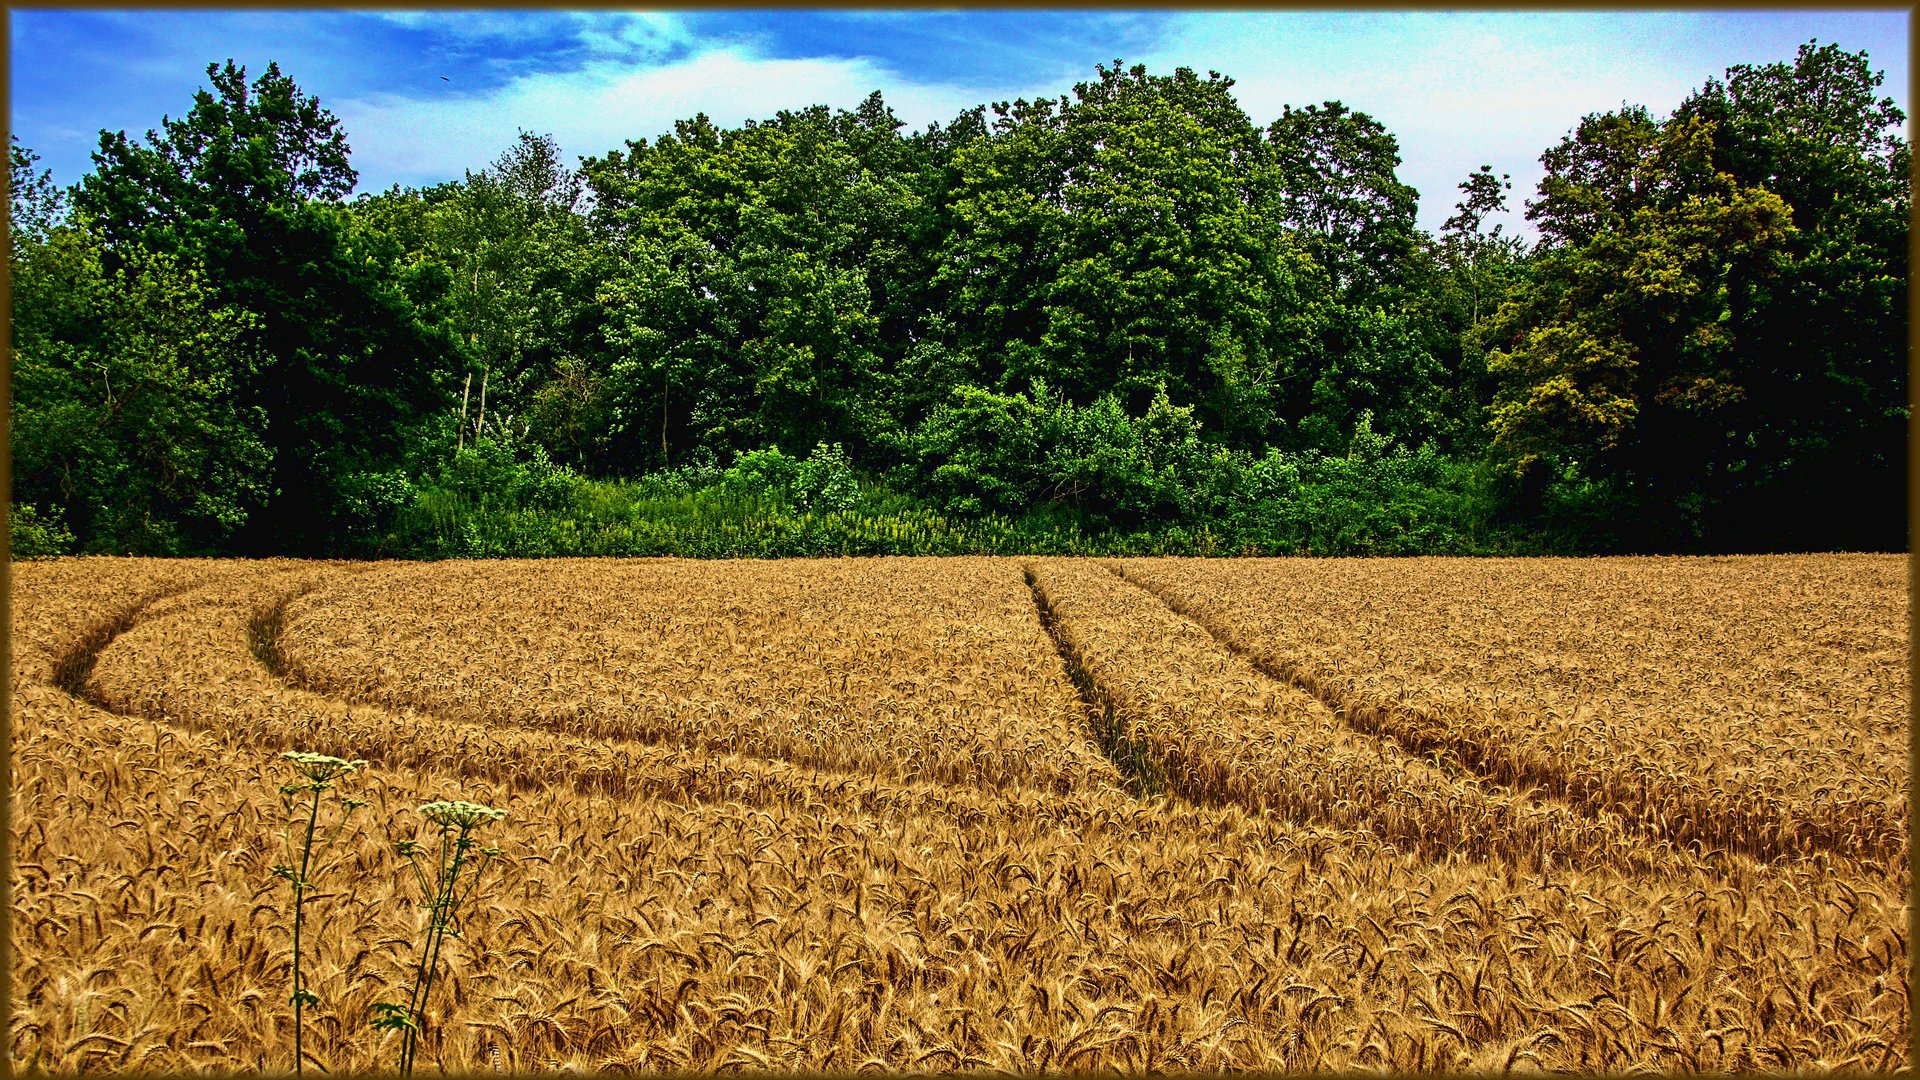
top-left (8, 42), bottom-right (1910, 555)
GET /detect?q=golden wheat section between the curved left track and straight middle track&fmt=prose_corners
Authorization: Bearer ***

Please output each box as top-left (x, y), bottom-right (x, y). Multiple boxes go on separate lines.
top-left (280, 559), bottom-right (1116, 792)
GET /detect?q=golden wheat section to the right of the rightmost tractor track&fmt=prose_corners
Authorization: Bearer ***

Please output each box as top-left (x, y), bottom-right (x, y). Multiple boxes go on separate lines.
top-left (1117, 555), bottom-right (1907, 872)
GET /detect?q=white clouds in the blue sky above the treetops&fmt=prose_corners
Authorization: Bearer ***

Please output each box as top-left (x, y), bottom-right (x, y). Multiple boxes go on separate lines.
top-left (328, 12), bottom-right (1904, 231)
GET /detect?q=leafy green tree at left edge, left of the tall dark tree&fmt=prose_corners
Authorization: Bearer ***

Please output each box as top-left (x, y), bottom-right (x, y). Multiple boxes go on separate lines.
top-left (12, 229), bottom-right (271, 555)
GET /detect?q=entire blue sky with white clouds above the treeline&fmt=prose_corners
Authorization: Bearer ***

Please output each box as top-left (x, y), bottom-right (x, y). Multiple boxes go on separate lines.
top-left (10, 8), bottom-right (1910, 229)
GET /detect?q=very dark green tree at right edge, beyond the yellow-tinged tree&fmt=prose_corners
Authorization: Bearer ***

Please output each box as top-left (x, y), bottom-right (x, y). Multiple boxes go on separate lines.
top-left (1676, 42), bottom-right (1912, 550)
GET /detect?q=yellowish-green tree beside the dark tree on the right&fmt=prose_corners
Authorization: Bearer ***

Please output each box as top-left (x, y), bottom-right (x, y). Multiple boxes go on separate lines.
top-left (1480, 99), bottom-right (1793, 546)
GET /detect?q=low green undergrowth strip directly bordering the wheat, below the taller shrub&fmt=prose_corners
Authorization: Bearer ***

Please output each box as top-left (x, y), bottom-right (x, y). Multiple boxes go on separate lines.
top-left (360, 432), bottom-right (1559, 559)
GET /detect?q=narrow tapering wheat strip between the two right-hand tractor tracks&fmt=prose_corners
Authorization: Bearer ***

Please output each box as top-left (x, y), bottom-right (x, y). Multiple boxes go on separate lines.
top-left (1033, 559), bottom-right (1692, 871)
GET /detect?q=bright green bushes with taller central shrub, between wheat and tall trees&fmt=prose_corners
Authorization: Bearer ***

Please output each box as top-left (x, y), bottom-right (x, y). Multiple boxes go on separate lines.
top-left (386, 405), bottom-right (1540, 557)
